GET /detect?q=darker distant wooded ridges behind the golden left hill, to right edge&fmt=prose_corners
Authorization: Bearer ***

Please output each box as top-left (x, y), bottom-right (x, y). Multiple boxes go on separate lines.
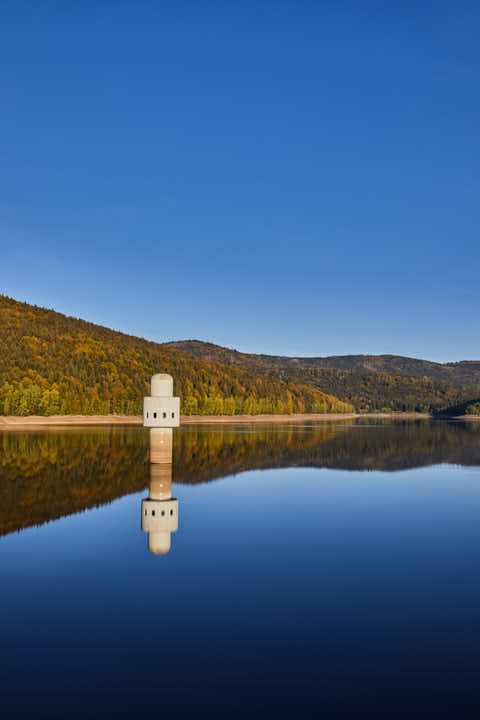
top-left (166, 340), bottom-right (480, 412)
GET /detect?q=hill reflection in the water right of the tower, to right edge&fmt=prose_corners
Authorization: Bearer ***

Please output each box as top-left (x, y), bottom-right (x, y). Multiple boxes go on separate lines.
top-left (174, 421), bottom-right (480, 483)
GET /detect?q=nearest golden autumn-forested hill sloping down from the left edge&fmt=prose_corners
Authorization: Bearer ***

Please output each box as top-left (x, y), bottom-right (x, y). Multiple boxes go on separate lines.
top-left (0, 295), bottom-right (353, 415)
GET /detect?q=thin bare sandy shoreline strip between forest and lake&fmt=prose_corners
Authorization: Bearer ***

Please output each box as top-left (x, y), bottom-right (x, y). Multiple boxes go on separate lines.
top-left (0, 412), bottom-right (480, 430)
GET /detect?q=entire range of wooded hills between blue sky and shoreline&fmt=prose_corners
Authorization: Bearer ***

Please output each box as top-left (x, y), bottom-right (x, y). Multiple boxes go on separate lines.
top-left (0, 295), bottom-right (480, 415)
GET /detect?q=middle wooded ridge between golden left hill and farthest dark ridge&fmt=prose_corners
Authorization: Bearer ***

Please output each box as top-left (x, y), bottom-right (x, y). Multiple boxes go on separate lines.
top-left (168, 340), bottom-right (478, 413)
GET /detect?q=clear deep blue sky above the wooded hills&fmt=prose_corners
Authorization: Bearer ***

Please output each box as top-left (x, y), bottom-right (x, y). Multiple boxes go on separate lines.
top-left (0, 0), bottom-right (480, 361)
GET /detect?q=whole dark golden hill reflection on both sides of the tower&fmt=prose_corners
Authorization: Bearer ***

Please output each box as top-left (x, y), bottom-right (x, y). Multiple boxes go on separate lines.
top-left (0, 422), bottom-right (480, 534)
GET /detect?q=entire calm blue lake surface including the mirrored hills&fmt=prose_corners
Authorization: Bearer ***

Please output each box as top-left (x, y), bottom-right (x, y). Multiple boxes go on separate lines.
top-left (0, 420), bottom-right (480, 718)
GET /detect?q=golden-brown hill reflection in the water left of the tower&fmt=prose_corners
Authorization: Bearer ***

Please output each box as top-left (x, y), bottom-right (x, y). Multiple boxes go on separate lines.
top-left (0, 429), bottom-right (148, 535)
